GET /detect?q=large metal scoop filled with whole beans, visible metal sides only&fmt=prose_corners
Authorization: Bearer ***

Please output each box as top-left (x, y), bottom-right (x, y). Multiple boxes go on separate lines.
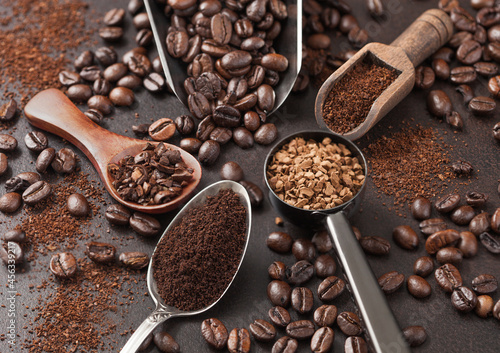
top-left (144, 0), bottom-right (302, 115)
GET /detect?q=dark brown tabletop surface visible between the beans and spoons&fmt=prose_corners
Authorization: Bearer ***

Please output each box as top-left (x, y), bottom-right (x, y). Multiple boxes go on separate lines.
top-left (0, 0), bottom-right (500, 352)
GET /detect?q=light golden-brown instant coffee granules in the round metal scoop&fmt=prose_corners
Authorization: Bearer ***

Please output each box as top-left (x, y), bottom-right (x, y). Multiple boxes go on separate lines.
top-left (266, 137), bottom-right (365, 210)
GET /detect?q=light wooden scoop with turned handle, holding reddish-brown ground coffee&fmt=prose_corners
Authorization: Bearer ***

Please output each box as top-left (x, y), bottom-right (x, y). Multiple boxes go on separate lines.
top-left (314, 9), bottom-right (453, 140)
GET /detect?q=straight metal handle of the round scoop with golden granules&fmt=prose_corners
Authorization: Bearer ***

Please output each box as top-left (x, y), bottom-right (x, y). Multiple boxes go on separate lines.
top-left (326, 212), bottom-right (410, 353)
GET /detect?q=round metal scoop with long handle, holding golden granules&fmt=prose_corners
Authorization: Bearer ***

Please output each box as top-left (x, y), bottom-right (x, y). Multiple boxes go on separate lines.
top-left (264, 131), bottom-right (410, 353)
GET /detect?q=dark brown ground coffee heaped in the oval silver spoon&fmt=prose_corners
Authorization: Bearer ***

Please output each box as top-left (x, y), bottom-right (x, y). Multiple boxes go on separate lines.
top-left (153, 189), bottom-right (247, 310)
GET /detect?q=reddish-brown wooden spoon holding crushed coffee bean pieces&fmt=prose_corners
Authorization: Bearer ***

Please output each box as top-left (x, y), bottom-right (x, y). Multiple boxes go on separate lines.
top-left (24, 88), bottom-right (201, 213)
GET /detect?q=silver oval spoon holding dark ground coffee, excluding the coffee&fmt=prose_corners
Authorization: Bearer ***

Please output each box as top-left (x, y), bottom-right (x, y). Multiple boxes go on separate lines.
top-left (120, 180), bottom-right (252, 353)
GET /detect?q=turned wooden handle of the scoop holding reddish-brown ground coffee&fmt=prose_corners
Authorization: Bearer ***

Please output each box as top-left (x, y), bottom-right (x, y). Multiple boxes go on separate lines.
top-left (391, 9), bottom-right (453, 67)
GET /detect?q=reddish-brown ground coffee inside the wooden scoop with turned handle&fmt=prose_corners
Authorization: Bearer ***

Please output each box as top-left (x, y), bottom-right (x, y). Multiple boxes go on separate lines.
top-left (323, 60), bottom-right (399, 134)
